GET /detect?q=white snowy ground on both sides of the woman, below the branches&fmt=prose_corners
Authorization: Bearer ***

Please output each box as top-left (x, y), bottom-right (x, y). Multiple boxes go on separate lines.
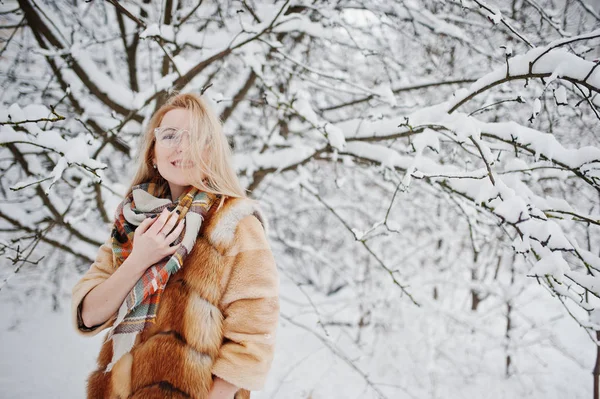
top-left (0, 268), bottom-right (595, 399)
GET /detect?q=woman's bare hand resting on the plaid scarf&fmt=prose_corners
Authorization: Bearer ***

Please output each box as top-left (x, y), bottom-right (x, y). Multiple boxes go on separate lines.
top-left (129, 208), bottom-right (185, 270)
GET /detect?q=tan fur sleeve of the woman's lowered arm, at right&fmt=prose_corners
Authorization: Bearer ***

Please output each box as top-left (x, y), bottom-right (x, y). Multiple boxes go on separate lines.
top-left (212, 215), bottom-right (279, 391)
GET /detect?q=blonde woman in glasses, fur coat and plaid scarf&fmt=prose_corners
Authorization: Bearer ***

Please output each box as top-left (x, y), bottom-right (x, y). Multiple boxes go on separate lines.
top-left (72, 94), bottom-right (279, 399)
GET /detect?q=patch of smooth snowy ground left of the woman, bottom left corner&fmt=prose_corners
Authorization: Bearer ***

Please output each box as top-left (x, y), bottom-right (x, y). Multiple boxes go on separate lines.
top-left (0, 296), bottom-right (101, 399)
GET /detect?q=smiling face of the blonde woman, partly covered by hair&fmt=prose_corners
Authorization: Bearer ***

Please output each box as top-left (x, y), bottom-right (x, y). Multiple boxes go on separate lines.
top-left (153, 108), bottom-right (194, 200)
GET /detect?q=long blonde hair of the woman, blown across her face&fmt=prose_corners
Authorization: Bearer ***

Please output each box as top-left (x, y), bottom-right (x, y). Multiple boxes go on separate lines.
top-left (127, 93), bottom-right (247, 207)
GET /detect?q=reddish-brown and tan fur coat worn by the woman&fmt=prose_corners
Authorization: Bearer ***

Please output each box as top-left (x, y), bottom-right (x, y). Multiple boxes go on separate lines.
top-left (71, 198), bottom-right (279, 399)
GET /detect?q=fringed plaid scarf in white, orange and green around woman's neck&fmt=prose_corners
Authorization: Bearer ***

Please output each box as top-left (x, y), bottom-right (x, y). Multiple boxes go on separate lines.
top-left (106, 183), bottom-right (217, 372)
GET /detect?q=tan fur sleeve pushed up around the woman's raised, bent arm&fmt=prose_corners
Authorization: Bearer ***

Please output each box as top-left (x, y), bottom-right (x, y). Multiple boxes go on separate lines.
top-left (71, 237), bottom-right (117, 336)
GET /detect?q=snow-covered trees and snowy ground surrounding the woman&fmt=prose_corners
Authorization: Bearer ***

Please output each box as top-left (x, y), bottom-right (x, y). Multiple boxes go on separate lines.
top-left (0, 0), bottom-right (600, 399)
